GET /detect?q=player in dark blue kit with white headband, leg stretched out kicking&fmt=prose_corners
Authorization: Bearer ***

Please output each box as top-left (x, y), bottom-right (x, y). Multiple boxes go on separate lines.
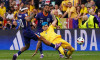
top-left (12, 7), bottom-right (61, 60)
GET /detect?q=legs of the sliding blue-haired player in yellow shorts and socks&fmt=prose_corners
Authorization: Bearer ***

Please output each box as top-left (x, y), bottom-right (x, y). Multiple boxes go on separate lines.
top-left (53, 38), bottom-right (74, 58)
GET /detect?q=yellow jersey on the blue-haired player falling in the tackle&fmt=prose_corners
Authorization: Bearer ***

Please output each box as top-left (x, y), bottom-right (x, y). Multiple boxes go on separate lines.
top-left (40, 25), bottom-right (61, 42)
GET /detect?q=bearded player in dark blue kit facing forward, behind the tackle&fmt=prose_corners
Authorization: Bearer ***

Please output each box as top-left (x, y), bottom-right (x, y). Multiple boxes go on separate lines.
top-left (33, 4), bottom-right (64, 58)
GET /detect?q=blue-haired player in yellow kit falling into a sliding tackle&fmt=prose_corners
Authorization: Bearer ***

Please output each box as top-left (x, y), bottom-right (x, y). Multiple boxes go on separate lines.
top-left (33, 14), bottom-right (74, 58)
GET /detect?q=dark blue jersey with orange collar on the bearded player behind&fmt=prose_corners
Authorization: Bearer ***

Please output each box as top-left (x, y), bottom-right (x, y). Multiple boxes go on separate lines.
top-left (35, 12), bottom-right (53, 32)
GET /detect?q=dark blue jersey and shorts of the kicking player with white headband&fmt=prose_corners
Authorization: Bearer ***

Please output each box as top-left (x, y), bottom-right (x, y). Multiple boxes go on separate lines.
top-left (18, 14), bottom-right (38, 44)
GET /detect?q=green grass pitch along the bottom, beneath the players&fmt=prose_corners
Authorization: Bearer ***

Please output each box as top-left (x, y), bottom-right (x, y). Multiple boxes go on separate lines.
top-left (0, 50), bottom-right (100, 60)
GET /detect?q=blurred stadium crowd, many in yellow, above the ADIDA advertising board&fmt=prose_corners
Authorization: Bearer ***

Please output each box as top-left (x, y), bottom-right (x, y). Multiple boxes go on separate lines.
top-left (0, 0), bottom-right (100, 30)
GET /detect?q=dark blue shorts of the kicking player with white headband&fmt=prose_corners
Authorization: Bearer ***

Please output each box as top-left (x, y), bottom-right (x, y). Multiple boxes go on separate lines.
top-left (23, 31), bottom-right (39, 44)
